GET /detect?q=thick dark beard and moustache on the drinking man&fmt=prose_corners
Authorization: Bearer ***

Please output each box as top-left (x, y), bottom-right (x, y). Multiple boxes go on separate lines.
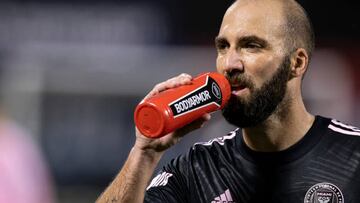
top-left (222, 56), bottom-right (290, 128)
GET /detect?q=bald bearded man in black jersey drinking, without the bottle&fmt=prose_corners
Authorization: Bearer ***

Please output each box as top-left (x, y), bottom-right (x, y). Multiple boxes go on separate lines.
top-left (98, 0), bottom-right (360, 203)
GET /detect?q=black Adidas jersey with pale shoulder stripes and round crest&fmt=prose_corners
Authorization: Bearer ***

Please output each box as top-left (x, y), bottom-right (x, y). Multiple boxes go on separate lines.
top-left (145, 116), bottom-right (360, 203)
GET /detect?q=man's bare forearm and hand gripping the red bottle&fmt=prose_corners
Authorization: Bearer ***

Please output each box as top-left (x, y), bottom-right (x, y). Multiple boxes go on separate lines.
top-left (96, 74), bottom-right (210, 203)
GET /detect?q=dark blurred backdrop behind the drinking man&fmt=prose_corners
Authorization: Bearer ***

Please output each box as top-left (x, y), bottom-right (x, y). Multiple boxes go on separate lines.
top-left (0, 0), bottom-right (360, 203)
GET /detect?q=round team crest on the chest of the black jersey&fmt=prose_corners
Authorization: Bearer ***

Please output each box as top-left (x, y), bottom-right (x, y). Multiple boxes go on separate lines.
top-left (304, 183), bottom-right (344, 203)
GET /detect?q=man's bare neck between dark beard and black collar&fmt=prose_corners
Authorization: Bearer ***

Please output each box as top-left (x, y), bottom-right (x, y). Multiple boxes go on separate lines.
top-left (243, 97), bottom-right (315, 152)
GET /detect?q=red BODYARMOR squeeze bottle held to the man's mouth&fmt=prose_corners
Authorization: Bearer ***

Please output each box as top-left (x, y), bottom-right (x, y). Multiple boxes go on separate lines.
top-left (134, 72), bottom-right (231, 138)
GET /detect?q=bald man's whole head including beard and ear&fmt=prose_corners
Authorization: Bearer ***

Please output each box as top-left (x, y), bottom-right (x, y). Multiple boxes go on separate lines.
top-left (216, 0), bottom-right (314, 127)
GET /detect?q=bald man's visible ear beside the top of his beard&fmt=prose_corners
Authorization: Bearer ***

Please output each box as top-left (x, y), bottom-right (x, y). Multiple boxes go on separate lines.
top-left (290, 48), bottom-right (309, 78)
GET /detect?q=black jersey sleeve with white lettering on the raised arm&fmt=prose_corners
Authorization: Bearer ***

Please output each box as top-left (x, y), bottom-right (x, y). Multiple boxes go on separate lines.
top-left (144, 157), bottom-right (189, 203)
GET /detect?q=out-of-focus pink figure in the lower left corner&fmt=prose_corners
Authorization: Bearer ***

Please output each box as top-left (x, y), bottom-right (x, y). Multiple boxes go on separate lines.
top-left (0, 112), bottom-right (55, 203)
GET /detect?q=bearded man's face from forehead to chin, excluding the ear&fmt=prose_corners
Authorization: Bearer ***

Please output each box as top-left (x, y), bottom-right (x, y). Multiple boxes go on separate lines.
top-left (216, 0), bottom-right (290, 127)
